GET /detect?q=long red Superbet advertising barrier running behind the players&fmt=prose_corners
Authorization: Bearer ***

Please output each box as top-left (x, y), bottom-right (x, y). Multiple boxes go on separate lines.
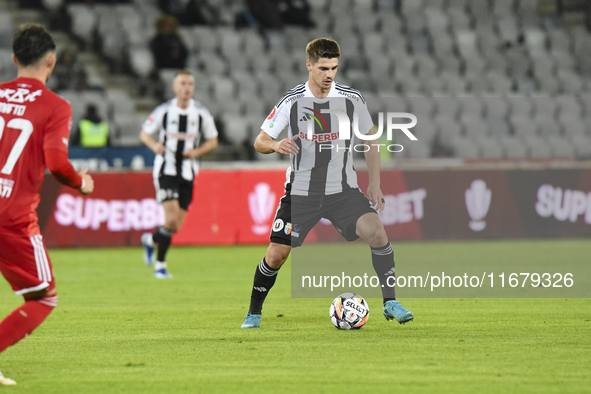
top-left (38, 169), bottom-right (591, 247)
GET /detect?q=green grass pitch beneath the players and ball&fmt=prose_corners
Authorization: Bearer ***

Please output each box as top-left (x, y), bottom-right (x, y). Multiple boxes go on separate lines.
top-left (0, 240), bottom-right (591, 394)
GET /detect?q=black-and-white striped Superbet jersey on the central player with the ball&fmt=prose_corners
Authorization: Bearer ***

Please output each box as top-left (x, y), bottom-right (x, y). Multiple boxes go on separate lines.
top-left (261, 82), bottom-right (374, 196)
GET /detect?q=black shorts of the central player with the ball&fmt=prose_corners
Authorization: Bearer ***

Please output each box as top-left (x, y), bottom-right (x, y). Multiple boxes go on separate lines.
top-left (271, 185), bottom-right (376, 248)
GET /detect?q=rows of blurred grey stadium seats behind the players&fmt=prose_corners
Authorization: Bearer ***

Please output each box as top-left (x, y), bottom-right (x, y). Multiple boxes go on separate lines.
top-left (0, 0), bottom-right (591, 159)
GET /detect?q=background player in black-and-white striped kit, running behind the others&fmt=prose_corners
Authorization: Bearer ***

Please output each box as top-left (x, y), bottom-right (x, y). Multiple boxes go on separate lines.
top-left (140, 70), bottom-right (218, 279)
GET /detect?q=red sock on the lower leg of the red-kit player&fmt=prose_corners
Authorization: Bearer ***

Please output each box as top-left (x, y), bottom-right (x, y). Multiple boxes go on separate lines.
top-left (0, 296), bottom-right (57, 353)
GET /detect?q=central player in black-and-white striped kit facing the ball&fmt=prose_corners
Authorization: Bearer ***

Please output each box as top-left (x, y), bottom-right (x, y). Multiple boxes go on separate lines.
top-left (242, 38), bottom-right (414, 328)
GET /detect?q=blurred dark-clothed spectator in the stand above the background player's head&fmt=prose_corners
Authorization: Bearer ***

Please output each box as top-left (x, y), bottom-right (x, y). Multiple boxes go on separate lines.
top-left (150, 15), bottom-right (188, 70)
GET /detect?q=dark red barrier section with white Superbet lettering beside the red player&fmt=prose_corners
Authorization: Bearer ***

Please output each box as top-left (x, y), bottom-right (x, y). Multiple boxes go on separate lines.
top-left (37, 173), bottom-right (164, 247)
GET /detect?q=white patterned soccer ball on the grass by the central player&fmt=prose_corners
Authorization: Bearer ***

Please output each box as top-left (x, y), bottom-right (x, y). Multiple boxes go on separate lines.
top-left (329, 293), bottom-right (369, 330)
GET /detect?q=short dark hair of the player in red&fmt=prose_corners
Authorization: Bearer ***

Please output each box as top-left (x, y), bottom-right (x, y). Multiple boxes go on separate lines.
top-left (12, 23), bottom-right (55, 67)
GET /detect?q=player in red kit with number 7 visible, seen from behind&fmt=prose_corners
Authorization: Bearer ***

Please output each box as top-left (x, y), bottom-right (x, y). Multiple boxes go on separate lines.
top-left (0, 24), bottom-right (94, 385)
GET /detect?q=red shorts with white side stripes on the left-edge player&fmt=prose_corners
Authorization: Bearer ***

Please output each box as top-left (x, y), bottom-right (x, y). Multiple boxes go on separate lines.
top-left (0, 229), bottom-right (55, 295)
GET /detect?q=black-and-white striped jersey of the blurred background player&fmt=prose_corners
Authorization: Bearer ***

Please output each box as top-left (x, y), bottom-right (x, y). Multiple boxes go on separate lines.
top-left (142, 98), bottom-right (218, 181)
